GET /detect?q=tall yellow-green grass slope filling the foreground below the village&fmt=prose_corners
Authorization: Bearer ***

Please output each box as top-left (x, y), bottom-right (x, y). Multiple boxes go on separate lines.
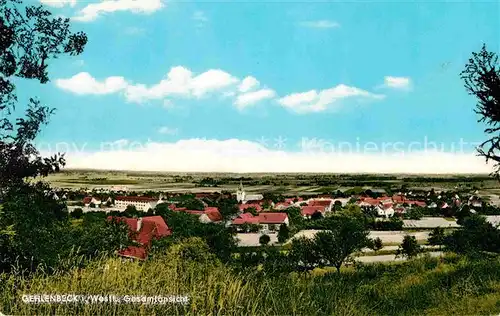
top-left (0, 255), bottom-right (500, 315)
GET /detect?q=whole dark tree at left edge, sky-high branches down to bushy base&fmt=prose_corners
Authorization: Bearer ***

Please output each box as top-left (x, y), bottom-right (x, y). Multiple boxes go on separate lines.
top-left (0, 0), bottom-right (87, 270)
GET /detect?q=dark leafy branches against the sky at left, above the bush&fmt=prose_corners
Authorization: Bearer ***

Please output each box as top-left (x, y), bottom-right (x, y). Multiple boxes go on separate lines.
top-left (0, 0), bottom-right (87, 190)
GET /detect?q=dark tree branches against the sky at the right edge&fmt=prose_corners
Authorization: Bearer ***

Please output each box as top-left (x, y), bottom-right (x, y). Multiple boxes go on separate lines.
top-left (460, 45), bottom-right (500, 178)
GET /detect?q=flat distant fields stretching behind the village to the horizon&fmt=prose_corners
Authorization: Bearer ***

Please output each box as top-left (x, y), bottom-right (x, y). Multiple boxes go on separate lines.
top-left (46, 170), bottom-right (500, 197)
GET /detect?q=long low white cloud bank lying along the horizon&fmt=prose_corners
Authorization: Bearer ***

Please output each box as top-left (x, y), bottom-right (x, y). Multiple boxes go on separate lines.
top-left (42, 139), bottom-right (491, 174)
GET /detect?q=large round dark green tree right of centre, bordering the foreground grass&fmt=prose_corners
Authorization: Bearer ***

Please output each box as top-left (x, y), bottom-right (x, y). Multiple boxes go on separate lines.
top-left (314, 216), bottom-right (370, 273)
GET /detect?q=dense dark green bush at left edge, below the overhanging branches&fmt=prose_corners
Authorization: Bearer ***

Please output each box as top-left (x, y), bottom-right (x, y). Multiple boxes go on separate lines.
top-left (0, 183), bottom-right (69, 271)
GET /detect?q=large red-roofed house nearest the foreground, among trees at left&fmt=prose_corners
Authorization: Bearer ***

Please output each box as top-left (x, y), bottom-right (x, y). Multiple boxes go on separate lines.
top-left (108, 216), bottom-right (172, 260)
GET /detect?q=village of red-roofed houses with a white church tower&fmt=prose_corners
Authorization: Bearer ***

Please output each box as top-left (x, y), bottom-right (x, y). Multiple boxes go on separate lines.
top-left (47, 182), bottom-right (500, 259)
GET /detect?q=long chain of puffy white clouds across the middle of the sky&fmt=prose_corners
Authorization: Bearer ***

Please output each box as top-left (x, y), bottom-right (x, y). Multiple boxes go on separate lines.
top-left (55, 66), bottom-right (384, 113)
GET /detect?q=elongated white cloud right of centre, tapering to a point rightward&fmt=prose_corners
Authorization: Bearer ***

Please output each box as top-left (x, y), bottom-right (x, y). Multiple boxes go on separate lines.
top-left (278, 84), bottom-right (384, 113)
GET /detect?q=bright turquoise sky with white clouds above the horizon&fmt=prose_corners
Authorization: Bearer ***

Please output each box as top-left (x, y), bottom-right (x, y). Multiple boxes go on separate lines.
top-left (18, 0), bottom-right (500, 173)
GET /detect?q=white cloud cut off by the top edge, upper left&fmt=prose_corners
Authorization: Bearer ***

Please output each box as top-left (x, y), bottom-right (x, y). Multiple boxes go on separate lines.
top-left (73, 0), bottom-right (163, 22)
